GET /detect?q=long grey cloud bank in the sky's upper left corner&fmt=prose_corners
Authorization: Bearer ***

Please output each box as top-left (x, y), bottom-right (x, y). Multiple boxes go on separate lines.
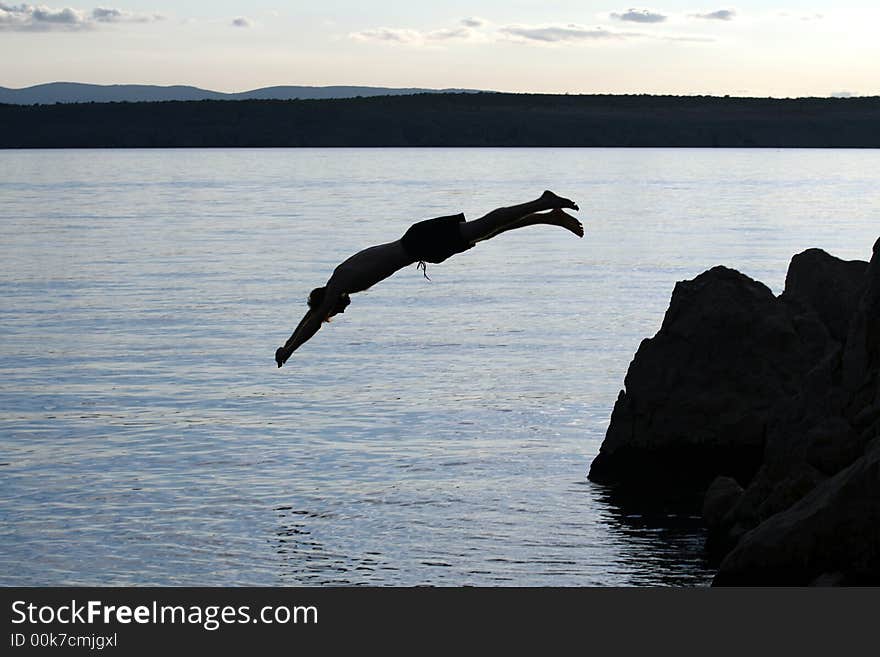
top-left (0, 2), bottom-right (163, 32)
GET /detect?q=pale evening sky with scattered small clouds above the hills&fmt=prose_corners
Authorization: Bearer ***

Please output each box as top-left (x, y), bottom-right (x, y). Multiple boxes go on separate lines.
top-left (0, 0), bottom-right (880, 97)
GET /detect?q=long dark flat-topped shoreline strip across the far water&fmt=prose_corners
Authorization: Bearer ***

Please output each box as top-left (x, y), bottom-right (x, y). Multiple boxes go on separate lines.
top-left (0, 93), bottom-right (880, 149)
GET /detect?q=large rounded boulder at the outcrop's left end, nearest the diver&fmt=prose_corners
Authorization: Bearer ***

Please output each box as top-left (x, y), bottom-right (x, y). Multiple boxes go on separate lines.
top-left (590, 267), bottom-right (827, 484)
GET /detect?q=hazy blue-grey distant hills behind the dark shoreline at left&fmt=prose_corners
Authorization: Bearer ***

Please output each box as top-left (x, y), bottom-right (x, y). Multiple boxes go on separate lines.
top-left (0, 82), bottom-right (488, 105)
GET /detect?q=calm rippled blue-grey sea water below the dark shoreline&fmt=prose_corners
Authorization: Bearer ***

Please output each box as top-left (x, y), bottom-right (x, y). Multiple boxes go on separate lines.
top-left (0, 149), bottom-right (880, 586)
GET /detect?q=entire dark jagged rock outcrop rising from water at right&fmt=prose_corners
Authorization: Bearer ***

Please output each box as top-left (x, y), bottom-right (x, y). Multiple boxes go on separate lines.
top-left (590, 240), bottom-right (880, 585)
